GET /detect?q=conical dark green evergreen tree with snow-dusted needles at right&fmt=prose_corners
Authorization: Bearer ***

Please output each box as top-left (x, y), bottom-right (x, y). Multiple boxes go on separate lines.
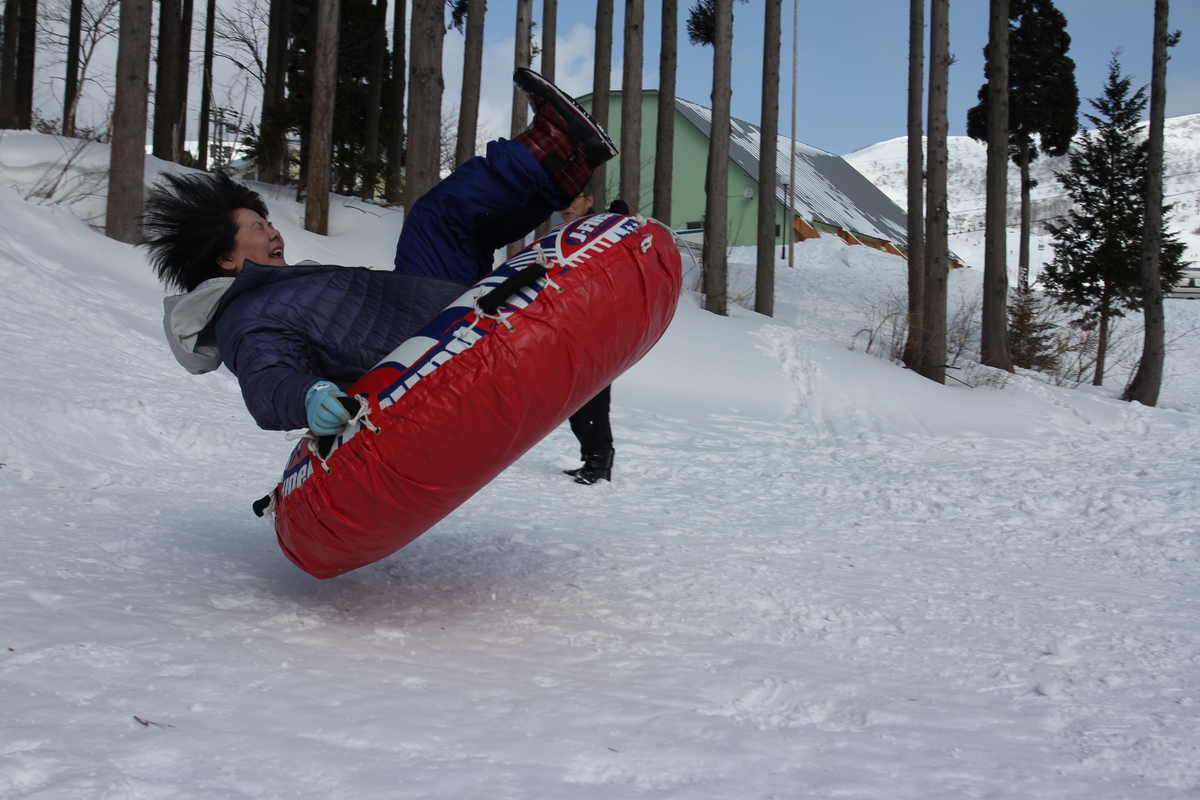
top-left (1042, 54), bottom-right (1183, 386)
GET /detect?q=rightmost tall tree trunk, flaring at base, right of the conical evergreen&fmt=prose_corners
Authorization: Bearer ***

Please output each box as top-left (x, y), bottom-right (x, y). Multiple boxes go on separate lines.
top-left (1124, 0), bottom-right (1169, 405)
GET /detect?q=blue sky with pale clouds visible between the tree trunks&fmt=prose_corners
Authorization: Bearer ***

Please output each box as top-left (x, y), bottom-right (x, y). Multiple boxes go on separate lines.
top-left (456, 0), bottom-right (1200, 154)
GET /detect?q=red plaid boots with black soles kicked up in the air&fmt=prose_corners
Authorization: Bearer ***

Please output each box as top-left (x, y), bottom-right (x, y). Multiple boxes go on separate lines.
top-left (512, 68), bottom-right (617, 197)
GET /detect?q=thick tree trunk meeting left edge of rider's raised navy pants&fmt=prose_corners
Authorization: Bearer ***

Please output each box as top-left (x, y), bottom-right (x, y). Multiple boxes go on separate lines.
top-left (404, 0), bottom-right (446, 209)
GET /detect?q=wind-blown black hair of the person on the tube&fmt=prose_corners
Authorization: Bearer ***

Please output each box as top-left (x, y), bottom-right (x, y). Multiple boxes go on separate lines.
top-left (142, 173), bottom-right (266, 291)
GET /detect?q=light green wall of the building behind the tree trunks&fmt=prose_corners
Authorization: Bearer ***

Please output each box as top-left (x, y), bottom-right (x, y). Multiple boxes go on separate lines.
top-left (578, 91), bottom-right (784, 247)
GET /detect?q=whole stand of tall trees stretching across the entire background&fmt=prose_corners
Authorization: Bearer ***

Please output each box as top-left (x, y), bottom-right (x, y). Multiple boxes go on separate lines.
top-left (0, 0), bottom-right (1182, 404)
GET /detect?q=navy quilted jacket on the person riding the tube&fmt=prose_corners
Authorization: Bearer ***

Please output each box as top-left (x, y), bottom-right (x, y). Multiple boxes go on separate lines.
top-left (216, 261), bottom-right (467, 431)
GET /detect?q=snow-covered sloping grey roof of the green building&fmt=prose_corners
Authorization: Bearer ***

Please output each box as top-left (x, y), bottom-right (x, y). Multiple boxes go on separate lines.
top-left (676, 97), bottom-right (908, 246)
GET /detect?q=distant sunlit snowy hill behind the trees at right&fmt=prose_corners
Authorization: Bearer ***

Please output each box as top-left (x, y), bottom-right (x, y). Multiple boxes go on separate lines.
top-left (842, 114), bottom-right (1200, 276)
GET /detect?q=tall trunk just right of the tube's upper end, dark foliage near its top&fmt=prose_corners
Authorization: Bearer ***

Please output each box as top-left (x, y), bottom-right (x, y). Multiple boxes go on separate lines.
top-left (701, 0), bottom-right (733, 317)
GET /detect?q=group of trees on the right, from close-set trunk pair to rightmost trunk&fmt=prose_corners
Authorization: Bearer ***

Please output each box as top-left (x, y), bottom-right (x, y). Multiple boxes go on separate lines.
top-left (904, 0), bottom-right (1183, 405)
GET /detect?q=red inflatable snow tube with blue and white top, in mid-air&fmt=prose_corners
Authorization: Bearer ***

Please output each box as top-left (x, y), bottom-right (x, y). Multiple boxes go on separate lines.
top-left (272, 213), bottom-right (680, 578)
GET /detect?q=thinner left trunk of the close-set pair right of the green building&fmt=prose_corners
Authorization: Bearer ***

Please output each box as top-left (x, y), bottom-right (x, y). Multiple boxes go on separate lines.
top-left (904, 0), bottom-right (925, 369)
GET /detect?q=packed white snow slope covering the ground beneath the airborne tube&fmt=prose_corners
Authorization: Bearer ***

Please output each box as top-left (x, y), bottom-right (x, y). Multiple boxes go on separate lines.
top-left (7, 136), bottom-right (1200, 800)
